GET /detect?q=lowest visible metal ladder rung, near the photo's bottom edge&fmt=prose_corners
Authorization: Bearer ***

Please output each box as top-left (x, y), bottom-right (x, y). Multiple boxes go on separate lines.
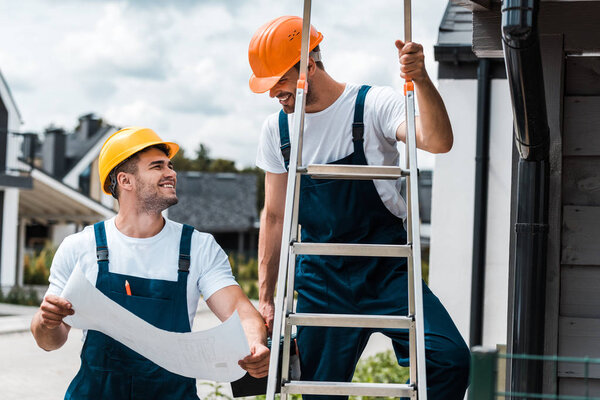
top-left (281, 382), bottom-right (415, 397)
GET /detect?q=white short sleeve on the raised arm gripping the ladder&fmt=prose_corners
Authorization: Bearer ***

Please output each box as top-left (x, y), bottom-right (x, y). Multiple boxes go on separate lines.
top-left (373, 86), bottom-right (405, 142)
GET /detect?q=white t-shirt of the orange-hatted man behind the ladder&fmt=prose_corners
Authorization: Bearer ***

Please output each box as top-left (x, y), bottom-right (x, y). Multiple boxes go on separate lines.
top-left (256, 83), bottom-right (406, 219)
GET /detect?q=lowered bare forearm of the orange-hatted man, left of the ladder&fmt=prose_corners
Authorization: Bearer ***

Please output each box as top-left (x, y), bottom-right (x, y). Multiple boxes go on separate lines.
top-left (258, 210), bottom-right (283, 302)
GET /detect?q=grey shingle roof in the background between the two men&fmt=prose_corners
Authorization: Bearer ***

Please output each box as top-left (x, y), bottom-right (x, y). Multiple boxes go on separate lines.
top-left (169, 172), bottom-right (258, 233)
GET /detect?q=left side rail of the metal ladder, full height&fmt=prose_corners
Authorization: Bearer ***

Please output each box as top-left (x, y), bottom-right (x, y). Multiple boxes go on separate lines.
top-left (266, 0), bottom-right (311, 400)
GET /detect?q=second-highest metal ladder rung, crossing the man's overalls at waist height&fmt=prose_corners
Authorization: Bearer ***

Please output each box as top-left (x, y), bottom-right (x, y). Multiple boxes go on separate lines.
top-left (294, 242), bottom-right (412, 257)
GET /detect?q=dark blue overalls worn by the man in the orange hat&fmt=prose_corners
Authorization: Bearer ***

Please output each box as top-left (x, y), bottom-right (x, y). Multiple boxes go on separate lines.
top-left (279, 86), bottom-right (470, 400)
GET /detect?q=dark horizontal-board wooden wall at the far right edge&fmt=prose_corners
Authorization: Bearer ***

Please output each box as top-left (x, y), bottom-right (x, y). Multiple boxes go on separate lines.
top-left (558, 57), bottom-right (600, 396)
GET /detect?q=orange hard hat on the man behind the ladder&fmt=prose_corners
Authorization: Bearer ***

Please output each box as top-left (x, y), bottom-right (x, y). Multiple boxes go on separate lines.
top-left (248, 16), bottom-right (323, 93)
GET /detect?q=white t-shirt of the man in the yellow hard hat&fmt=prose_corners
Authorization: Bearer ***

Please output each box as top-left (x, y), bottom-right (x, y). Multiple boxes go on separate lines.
top-left (47, 217), bottom-right (237, 326)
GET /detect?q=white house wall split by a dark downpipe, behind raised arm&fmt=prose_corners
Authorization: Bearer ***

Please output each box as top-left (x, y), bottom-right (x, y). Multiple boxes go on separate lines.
top-left (429, 79), bottom-right (512, 346)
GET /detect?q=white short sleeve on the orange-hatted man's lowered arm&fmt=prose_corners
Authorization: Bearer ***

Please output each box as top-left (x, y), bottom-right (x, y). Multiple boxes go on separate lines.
top-left (256, 114), bottom-right (287, 174)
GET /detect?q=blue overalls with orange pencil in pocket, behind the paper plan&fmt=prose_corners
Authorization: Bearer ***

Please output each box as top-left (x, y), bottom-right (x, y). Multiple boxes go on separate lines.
top-left (65, 222), bottom-right (198, 400)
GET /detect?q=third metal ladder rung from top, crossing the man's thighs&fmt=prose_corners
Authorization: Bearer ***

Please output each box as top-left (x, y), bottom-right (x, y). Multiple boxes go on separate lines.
top-left (287, 313), bottom-right (413, 329)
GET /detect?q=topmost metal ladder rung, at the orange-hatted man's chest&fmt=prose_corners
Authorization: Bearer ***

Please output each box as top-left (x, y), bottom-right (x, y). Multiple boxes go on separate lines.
top-left (299, 164), bottom-right (410, 180)
